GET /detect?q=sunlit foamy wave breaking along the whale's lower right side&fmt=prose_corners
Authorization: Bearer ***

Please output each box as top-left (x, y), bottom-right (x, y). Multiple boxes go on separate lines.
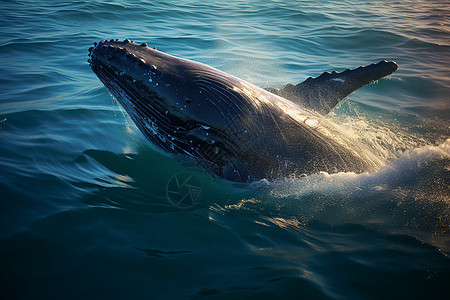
top-left (236, 139), bottom-right (450, 252)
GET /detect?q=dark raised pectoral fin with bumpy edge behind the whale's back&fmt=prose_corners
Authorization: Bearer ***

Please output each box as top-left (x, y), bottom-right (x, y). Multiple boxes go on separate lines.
top-left (268, 60), bottom-right (398, 115)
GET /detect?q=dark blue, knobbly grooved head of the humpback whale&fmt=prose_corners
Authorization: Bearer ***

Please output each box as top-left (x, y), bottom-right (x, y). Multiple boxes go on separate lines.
top-left (88, 40), bottom-right (252, 182)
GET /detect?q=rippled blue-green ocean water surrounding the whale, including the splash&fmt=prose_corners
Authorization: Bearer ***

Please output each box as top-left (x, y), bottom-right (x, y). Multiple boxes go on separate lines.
top-left (0, 0), bottom-right (450, 299)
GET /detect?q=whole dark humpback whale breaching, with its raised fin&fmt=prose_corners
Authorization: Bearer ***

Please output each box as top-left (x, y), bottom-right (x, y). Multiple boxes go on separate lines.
top-left (88, 39), bottom-right (398, 182)
